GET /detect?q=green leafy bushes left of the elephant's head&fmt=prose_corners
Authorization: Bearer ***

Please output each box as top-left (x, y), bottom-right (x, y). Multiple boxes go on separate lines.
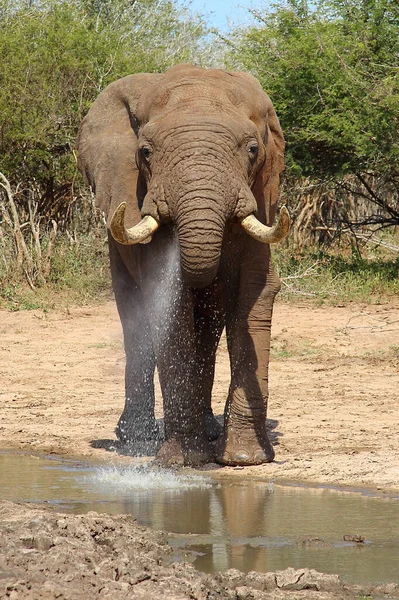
top-left (0, 0), bottom-right (205, 220)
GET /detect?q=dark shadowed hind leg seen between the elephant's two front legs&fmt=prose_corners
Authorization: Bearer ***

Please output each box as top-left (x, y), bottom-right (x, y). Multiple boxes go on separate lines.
top-left (193, 282), bottom-right (225, 441)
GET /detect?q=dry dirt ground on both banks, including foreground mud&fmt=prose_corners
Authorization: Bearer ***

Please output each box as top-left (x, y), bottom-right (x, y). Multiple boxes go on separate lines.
top-left (0, 302), bottom-right (399, 600)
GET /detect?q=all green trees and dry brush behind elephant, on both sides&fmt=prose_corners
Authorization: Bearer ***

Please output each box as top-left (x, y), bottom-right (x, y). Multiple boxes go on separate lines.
top-left (0, 0), bottom-right (399, 298)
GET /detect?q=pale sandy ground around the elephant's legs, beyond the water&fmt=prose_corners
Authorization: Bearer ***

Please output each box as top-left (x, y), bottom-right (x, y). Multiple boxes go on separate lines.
top-left (0, 302), bottom-right (399, 492)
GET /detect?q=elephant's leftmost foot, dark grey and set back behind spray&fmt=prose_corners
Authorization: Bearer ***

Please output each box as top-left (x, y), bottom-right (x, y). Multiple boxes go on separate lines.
top-left (115, 414), bottom-right (163, 456)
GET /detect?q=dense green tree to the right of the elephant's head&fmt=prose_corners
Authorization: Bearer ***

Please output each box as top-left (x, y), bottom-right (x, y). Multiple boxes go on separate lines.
top-left (228, 0), bottom-right (399, 226)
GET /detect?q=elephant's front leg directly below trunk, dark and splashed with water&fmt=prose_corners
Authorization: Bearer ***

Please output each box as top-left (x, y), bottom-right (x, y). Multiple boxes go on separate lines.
top-left (142, 274), bottom-right (213, 466)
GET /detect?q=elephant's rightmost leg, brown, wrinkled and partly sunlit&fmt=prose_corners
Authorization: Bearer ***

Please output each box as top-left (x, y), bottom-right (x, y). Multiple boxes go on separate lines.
top-left (217, 245), bottom-right (280, 465)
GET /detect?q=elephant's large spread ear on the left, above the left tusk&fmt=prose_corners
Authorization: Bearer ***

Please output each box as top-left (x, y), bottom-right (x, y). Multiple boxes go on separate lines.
top-left (77, 73), bottom-right (160, 227)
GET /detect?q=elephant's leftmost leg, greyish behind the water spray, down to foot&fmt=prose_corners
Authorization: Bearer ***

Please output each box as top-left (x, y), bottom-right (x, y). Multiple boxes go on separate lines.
top-left (110, 240), bottom-right (160, 455)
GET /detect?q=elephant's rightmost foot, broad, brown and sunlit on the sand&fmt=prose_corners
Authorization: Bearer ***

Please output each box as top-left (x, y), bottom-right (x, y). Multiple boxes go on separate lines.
top-left (216, 429), bottom-right (274, 467)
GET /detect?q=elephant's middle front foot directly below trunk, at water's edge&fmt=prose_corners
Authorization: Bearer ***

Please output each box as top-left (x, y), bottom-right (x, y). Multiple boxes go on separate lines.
top-left (155, 437), bottom-right (213, 467)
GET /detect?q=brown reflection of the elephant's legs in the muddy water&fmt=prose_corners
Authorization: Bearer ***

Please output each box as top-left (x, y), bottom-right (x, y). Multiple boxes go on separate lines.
top-left (104, 483), bottom-right (273, 571)
